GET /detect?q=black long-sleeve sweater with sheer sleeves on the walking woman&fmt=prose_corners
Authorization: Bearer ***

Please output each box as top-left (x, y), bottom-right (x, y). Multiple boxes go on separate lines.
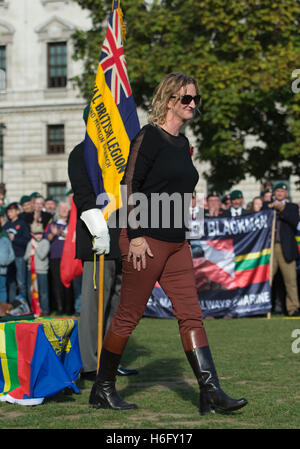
top-left (122, 124), bottom-right (199, 242)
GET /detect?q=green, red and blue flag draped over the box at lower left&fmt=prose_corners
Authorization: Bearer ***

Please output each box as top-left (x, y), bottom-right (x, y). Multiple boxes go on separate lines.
top-left (0, 318), bottom-right (82, 405)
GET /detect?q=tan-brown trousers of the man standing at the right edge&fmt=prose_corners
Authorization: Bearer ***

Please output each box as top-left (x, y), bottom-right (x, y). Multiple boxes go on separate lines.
top-left (272, 243), bottom-right (299, 315)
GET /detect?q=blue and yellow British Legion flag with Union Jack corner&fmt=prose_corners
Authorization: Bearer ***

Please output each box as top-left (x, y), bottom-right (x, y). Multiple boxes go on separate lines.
top-left (84, 0), bottom-right (140, 219)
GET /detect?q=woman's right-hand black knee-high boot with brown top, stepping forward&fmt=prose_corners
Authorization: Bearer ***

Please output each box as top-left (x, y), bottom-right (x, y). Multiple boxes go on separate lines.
top-left (183, 331), bottom-right (248, 415)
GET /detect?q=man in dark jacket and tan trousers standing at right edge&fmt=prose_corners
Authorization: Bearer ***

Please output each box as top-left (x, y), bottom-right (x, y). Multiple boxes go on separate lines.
top-left (268, 182), bottom-right (300, 316)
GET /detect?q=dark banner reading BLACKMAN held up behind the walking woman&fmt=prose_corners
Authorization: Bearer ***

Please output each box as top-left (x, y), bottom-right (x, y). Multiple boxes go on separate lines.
top-left (145, 210), bottom-right (274, 317)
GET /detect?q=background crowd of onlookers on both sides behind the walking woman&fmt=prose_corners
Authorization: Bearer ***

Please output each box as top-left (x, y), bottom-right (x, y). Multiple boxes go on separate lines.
top-left (0, 175), bottom-right (300, 316)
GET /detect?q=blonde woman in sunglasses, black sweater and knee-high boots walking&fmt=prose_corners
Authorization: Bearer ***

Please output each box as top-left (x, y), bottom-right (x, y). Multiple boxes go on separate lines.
top-left (89, 73), bottom-right (247, 414)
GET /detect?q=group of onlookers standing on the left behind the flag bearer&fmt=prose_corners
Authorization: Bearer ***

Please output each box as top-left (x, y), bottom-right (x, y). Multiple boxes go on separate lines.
top-left (0, 185), bottom-right (81, 316)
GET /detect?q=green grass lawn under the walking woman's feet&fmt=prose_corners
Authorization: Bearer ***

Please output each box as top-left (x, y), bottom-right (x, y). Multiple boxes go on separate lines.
top-left (0, 317), bottom-right (300, 429)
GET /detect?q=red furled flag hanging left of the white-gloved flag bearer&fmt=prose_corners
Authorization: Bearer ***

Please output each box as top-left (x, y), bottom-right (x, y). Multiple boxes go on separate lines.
top-left (60, 200), bottom-right (82, 288)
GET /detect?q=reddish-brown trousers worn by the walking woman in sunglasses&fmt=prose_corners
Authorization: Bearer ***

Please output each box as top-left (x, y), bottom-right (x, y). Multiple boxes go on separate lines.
top-left (104, 229), bottom-right (208, 350)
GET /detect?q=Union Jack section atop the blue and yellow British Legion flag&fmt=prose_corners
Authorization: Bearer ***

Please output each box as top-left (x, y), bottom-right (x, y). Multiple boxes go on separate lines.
top-left (100, 1), bottom-right (132, 105)
